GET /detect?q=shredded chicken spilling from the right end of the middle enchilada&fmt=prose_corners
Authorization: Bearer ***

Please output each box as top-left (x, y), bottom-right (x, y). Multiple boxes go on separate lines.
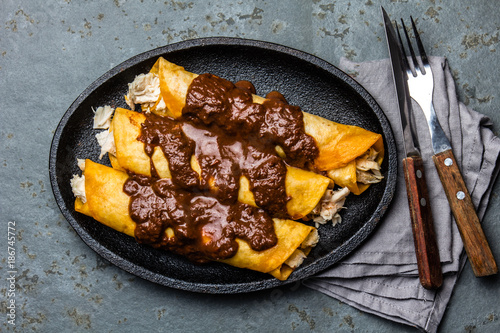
top-left (311, 187), bottom-right (350, 227)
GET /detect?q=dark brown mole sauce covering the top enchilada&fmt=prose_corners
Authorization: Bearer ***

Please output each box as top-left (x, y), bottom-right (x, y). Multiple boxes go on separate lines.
top-left (182, 74), bottom-right (319, 168)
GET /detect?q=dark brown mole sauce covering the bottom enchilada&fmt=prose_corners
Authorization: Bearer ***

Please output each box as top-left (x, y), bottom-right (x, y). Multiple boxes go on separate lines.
top-left (123, 175), bottom-right (277, 263)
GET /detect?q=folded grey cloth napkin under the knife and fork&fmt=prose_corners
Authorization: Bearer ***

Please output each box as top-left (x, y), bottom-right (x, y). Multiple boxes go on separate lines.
top-left (304, 57), bottom-right (500, 332)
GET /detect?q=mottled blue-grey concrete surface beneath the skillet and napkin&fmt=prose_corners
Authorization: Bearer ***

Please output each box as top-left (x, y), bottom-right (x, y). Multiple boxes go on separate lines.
top-left (0, 0), bottom-right (500, 332)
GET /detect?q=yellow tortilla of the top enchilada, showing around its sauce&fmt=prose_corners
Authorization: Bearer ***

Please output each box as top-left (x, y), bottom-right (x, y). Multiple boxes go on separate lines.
top-left (150, 57), bottom-right (384, 192)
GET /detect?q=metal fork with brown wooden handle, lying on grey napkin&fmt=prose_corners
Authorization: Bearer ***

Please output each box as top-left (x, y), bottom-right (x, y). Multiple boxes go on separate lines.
top-left (396, 16), bottom-right (498, 277)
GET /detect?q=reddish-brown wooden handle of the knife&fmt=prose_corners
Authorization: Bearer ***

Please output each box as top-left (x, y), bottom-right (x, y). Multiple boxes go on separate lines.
top-left (403, 156), bottom-right (443, 289)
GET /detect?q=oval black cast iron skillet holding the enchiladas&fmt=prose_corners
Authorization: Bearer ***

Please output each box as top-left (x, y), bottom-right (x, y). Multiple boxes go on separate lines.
top-left (49, 37), bottom-right (397, 293)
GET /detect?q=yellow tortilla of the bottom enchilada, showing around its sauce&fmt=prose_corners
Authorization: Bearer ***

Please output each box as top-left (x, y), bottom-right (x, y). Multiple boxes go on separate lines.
top-left (75, 160), bottom-right (317, 280)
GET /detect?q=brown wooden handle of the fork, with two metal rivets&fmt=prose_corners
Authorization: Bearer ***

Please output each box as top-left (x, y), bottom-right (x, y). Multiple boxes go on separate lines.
top-left (432, 149), bottom-right (498, 277)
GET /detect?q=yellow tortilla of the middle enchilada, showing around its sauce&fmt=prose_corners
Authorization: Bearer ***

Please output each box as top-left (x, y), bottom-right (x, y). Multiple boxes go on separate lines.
top-left (112, 108), bottom-right (331, 219)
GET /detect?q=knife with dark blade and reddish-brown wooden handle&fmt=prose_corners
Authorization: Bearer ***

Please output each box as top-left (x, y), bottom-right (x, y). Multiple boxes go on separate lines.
top-left (382, 8), bottom-right (443, 289)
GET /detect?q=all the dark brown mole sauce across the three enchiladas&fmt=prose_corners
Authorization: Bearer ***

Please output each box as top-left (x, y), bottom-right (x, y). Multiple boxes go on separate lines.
top-left (127, 74), bottom-right (318, 263)
